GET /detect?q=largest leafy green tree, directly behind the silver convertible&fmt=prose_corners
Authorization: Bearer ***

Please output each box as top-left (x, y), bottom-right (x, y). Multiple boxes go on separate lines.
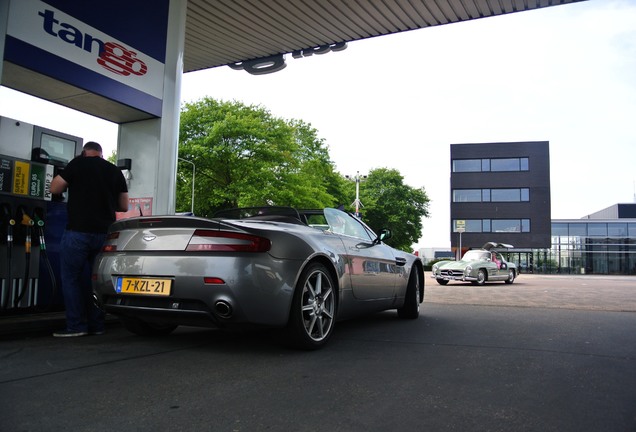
top-left (177, 98), bottom-right (340, 217)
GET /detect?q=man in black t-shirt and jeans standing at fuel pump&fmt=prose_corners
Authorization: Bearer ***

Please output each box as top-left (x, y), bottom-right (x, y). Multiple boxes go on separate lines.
top-left (51, 141), bottom-right (128, 337)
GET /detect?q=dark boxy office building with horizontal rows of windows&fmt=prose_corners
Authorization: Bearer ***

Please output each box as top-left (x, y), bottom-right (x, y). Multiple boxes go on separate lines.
top-left (450, 141), bottom-right (551, 249)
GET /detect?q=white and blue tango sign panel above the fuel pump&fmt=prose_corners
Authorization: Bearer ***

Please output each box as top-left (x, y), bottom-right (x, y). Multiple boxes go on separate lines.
top-left (5, 0), bottom-right (164, 100)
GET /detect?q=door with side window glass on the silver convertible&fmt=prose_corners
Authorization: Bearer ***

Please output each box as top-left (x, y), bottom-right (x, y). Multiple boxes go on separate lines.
top-left (325, 209), bottom-right (401, 300)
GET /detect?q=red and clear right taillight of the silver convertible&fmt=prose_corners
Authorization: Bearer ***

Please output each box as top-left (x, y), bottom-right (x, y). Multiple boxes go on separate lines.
top-left (186, 230), bottom-right (272, 252)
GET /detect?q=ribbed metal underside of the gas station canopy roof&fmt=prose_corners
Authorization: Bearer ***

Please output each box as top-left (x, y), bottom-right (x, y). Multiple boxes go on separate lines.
top-left (184, 0), bottom-right (579, 72)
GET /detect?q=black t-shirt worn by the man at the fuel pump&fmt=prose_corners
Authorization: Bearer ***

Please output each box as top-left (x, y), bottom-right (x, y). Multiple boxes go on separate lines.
top-left (60, 157), bottom-right (128, 233)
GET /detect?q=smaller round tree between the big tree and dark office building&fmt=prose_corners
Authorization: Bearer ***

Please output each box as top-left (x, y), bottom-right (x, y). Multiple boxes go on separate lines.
top-left (360, 168), bottom-right (430, 252)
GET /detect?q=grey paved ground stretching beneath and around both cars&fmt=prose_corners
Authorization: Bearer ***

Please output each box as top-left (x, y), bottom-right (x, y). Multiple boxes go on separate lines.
top-left (0, 275), bottom-right (636, 432)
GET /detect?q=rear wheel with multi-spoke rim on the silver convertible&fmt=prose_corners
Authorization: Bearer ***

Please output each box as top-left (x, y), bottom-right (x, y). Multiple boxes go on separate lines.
top-left (287, 263), bottom-right (337, 350)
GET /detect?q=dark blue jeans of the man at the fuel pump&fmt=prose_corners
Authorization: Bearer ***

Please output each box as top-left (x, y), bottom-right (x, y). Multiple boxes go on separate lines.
top-left (60, 230), bottom-right (106, 332)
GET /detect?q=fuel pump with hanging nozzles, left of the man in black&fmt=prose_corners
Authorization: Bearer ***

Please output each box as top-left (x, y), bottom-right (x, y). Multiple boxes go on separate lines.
top-left (0, 117), bottom-right (83, 318)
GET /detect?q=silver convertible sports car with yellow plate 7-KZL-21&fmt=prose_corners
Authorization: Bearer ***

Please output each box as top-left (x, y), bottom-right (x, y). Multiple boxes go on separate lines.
top-left (93, 207), bottom-right (424, 349)
